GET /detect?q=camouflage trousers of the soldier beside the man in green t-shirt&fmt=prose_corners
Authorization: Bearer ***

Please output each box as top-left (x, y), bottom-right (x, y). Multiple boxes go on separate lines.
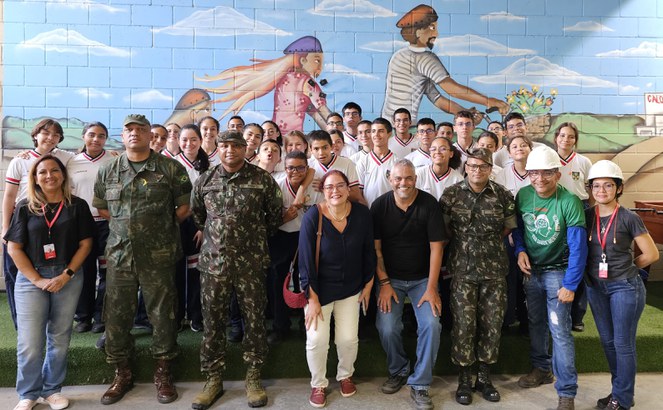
top-left (451, 276), bottom-right (506, 366)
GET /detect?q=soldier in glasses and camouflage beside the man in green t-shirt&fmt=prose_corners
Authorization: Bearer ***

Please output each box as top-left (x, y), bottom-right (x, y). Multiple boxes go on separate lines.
top-left (440, 148), bottom-right (516, 404)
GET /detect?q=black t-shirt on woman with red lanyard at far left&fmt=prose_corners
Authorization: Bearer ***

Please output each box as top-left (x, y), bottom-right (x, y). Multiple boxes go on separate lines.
top-left (4, 196), bottom-right (94, 268)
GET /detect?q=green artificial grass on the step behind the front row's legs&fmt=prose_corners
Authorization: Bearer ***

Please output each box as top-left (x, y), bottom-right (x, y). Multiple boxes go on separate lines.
top-left (0, 282), bottom-right (663, 387)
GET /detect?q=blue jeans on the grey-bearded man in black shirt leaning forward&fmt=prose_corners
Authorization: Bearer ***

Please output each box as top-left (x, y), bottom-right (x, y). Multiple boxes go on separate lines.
top-left (375, 278), bottom-right (442, 389)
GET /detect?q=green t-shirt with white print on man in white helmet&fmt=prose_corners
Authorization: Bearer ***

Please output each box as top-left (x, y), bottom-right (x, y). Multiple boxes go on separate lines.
top-left (516, 184), bottom-right (585, 270)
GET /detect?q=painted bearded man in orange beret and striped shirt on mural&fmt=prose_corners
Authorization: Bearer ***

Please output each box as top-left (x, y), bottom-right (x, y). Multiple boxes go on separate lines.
top-left (382, 4), bottom-right (509, 123)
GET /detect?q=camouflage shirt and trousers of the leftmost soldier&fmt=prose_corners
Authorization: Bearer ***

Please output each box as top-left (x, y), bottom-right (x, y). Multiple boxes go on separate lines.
top-left (92, 152), bottom-right (191, 363)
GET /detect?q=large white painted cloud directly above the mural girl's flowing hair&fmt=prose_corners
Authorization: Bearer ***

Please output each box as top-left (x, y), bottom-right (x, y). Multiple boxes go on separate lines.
top-left (157, 6), bottom-right (292, 37)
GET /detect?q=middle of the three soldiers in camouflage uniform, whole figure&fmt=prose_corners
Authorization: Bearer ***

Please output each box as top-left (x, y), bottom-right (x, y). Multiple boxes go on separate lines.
top-left (191, 131), bottom-right (283, 409)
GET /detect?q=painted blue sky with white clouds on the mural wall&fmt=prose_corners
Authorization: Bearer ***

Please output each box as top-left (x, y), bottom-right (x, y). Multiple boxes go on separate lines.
top-left (3, 0), bottom-right (663, 134)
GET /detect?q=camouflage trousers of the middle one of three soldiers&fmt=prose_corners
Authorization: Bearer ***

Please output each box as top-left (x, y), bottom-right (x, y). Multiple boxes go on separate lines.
top-left (200, 271), bottom-right (267, 374)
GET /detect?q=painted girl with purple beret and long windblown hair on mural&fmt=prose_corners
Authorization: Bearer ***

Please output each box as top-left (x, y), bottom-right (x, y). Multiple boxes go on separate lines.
top-left (198, 36), bottom-right (330, 134)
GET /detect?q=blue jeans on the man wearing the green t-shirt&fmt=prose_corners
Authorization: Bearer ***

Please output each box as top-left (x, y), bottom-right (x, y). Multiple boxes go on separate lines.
top-left (525, 270), bottom-right (578, 397)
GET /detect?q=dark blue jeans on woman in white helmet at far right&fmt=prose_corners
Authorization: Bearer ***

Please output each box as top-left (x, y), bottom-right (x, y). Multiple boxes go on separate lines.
top-left (587, 275), bottom-right (647, 408)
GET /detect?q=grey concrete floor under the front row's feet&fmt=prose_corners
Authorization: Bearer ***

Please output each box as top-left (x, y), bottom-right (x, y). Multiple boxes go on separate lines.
top-left (0, 373), bottom-right (663, 410)
